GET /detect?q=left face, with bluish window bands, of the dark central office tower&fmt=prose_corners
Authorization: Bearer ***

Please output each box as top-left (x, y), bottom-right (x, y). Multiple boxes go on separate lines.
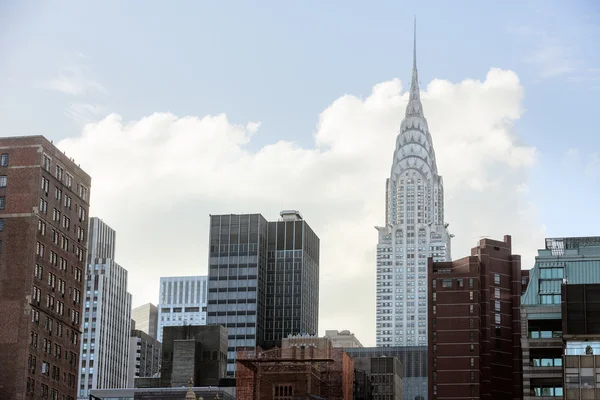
top-left (207, 214), bottom-right (267, 376)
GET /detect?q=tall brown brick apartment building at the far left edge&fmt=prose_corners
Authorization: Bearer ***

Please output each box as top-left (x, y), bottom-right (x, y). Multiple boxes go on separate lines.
top-left (0, 136), bottom-right (91, 400)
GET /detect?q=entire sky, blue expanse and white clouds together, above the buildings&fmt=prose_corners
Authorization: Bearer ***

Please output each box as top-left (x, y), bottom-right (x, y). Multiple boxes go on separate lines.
top-left (0, 0), bottom-right (600, 345)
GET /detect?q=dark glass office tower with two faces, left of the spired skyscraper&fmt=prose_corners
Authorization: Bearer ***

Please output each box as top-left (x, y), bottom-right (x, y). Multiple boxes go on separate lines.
top-left (207, 211), bottom-right (319, 376)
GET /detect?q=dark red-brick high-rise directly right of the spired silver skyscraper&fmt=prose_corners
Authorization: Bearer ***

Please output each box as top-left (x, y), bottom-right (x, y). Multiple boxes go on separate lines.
top-left (428, 236), bottom-right (522, 400)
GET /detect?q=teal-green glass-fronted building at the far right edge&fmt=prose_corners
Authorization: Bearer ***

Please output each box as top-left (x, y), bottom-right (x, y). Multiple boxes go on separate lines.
top-left (521, 237), bottom-right (600, 400)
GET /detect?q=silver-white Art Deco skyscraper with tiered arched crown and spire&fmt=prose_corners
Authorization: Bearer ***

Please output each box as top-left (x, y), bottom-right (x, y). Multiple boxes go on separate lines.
top-left (376, 25), bottom-right (451, 346)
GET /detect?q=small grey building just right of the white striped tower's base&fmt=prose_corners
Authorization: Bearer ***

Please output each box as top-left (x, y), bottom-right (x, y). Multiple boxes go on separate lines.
top-left (127, 329), bottom-right (162, 388)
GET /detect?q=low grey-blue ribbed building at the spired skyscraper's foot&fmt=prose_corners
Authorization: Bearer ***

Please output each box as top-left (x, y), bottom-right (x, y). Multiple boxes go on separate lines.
top-left (344, 346), bottom-right (428, 400)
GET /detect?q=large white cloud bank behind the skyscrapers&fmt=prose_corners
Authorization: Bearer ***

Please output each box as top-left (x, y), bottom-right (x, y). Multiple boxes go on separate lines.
top-left (59, 69), bottom-right (543, 344)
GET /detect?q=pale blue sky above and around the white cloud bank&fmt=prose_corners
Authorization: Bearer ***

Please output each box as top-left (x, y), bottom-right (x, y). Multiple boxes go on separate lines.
top-left (0, 0), bottom-right (600, 342)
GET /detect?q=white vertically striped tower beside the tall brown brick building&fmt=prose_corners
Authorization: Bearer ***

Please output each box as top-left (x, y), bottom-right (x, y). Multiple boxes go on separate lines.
top-left (79, 217), bottom-right (131, 400)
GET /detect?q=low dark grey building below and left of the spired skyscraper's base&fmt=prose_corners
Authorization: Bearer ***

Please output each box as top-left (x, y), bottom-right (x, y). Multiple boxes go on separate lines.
top-left (354, 357), bottom-right (404, 400)
